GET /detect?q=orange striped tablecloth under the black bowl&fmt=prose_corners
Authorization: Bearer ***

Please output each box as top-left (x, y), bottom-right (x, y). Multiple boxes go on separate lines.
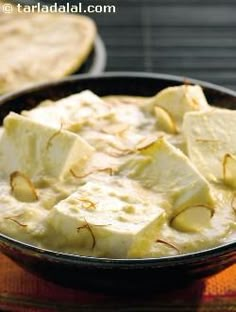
top-left (0, 254), bottom-right (236, 312)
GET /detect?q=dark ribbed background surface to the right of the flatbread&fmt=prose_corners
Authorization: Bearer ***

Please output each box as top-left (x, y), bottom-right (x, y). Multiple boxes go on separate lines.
top-left (85, 0), bottom-right (236, 90)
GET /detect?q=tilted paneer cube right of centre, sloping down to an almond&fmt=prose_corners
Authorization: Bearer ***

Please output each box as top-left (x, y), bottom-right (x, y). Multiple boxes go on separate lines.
top-left (120, 138), bottom-right (213, 215)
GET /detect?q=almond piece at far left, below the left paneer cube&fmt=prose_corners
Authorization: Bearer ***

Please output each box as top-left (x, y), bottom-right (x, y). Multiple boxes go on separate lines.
top-left (10, 171), bottom-right (38, 203)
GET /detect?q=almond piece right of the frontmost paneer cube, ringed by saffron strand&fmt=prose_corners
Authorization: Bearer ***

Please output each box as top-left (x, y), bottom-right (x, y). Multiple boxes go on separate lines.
top-left (171, 206), bottom-right (212, 232)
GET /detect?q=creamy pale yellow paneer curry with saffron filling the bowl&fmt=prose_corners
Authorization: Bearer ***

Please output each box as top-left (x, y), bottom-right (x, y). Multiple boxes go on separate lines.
top-left (0, 85), bottom-right (236, 259)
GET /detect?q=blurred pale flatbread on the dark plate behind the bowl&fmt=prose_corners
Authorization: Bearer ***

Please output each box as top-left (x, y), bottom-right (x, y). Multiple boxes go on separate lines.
top-left (0, 7), bottom-right (96, 94)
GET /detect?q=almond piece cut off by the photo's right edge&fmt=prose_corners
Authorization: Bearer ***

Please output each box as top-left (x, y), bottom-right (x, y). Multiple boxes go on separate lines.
top-left (223, 154), bottom-right (236, 188)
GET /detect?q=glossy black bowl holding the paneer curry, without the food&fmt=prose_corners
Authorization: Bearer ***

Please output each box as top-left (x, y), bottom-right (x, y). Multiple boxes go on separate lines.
top-left (0, 73), bottom-right (236, 293)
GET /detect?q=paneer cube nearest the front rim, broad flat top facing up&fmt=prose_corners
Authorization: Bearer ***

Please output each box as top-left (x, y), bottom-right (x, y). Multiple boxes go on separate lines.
top-left (48, 178), bottom-right (165, 258)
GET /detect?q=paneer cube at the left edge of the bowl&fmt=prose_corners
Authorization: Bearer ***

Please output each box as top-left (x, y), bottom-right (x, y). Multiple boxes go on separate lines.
top-left (0, 113), bottom-right (94, 179)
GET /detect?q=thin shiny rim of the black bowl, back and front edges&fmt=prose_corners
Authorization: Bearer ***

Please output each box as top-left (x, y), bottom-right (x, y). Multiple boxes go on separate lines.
top-left (0, 71), bottom-right (236, 267)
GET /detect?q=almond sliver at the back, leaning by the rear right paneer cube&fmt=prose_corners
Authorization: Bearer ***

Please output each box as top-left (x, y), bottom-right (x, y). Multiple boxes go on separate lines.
top-left (154, 106), bottom-right (177, 134)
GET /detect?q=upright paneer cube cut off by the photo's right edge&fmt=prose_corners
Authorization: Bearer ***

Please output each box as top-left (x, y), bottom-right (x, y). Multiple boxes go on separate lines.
top-left (183, 108), bottom-right (236, 188)
